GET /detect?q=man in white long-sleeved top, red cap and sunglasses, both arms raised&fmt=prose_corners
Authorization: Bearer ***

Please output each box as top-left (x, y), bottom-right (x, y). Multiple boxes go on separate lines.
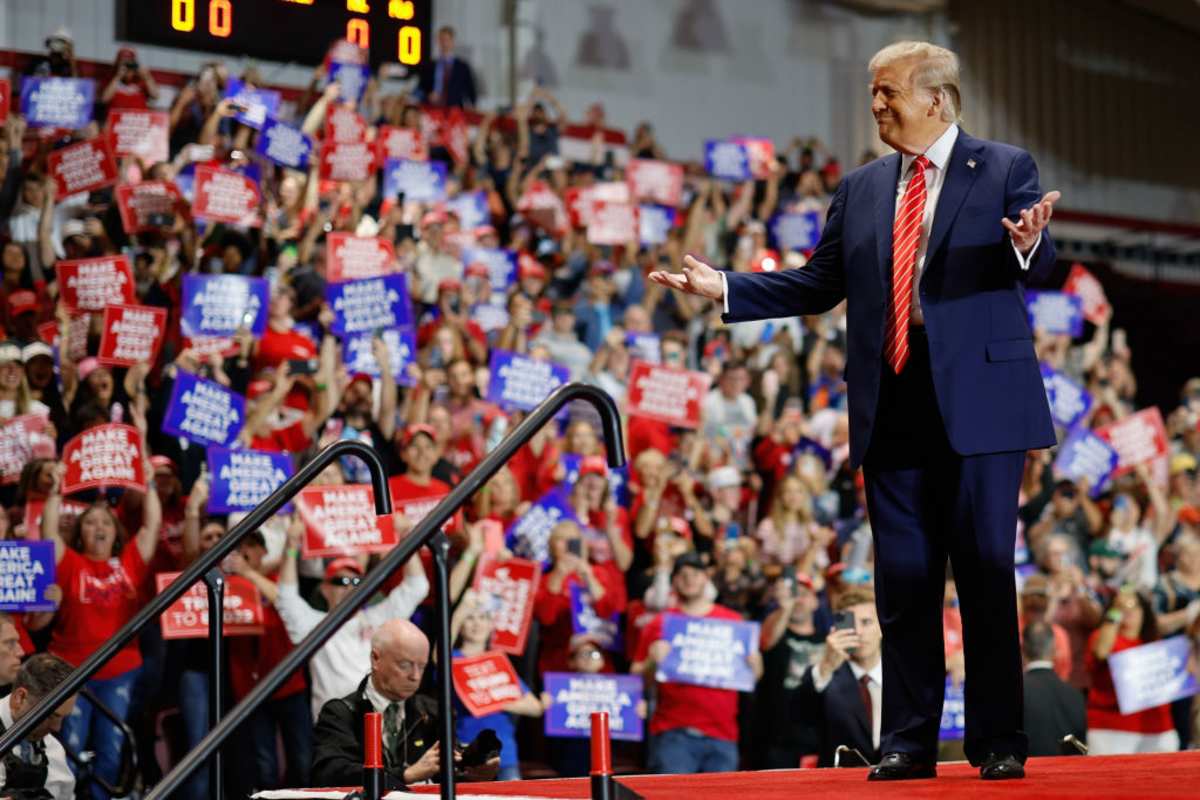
top-left (269, 515), bottom-right (430, 720)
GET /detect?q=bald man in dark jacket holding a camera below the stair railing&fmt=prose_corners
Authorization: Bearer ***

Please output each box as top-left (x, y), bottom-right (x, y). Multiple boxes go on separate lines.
top-left (312, 619), bottom-right (499, 789)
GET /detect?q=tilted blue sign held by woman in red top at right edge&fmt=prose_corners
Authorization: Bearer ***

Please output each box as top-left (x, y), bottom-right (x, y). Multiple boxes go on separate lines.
top-left (1109, 636), bottom-right (1196, 714)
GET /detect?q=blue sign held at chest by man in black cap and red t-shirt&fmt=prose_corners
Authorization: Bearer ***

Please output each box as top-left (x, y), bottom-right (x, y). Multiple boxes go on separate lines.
top-left (656, 614), bottom-right (758, 692)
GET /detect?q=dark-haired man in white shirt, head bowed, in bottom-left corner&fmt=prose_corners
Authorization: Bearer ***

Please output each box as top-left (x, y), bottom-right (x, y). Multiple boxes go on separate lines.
top-left (0, 652), bottom-right (74, 800)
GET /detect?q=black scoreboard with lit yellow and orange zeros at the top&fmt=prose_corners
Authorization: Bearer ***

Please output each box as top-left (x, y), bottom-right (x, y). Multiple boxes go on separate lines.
top-left (116, 0), bottom-right (433, 67)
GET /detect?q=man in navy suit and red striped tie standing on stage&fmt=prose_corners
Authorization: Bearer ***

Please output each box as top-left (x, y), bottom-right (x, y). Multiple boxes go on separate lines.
top-left (650, 42), bottom-right (1058, 780)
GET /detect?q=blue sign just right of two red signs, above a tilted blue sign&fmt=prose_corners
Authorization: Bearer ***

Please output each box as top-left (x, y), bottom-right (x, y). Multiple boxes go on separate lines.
top-left (180, 273), bottom-right (270, 338)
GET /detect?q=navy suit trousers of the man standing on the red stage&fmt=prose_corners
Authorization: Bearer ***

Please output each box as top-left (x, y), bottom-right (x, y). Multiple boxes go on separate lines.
top-left (864, 327), bottom-right (1028, 765)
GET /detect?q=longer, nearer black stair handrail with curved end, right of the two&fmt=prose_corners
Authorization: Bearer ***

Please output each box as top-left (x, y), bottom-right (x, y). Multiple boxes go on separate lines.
top-left (143, 384), bottom-right (625, 800)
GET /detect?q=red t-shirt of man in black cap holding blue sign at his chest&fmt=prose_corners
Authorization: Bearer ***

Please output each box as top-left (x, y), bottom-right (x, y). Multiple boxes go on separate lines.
top-left (635, 603), bottom-right (742, 741)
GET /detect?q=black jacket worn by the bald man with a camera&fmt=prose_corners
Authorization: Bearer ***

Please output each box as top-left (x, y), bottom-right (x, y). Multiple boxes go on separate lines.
top-left (312, 678), bottom-right (438, 789)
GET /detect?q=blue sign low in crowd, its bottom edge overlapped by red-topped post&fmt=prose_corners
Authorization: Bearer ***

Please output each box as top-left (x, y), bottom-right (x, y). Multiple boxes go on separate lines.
top-left (545, 672), bottom-right (643, 741)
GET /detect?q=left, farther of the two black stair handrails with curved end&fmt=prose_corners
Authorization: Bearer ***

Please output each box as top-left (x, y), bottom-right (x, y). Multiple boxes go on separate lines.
top-left (0, 439), bottom-right (391, 757)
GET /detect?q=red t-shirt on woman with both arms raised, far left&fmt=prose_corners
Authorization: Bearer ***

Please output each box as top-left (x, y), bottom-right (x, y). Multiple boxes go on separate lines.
top-left (49, 540), bottom-right (149, 680)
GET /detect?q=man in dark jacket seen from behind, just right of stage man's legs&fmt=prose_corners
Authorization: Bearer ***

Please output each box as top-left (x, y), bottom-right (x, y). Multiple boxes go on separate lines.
top-left (1021, 621), bottom-right (1087, 756)
